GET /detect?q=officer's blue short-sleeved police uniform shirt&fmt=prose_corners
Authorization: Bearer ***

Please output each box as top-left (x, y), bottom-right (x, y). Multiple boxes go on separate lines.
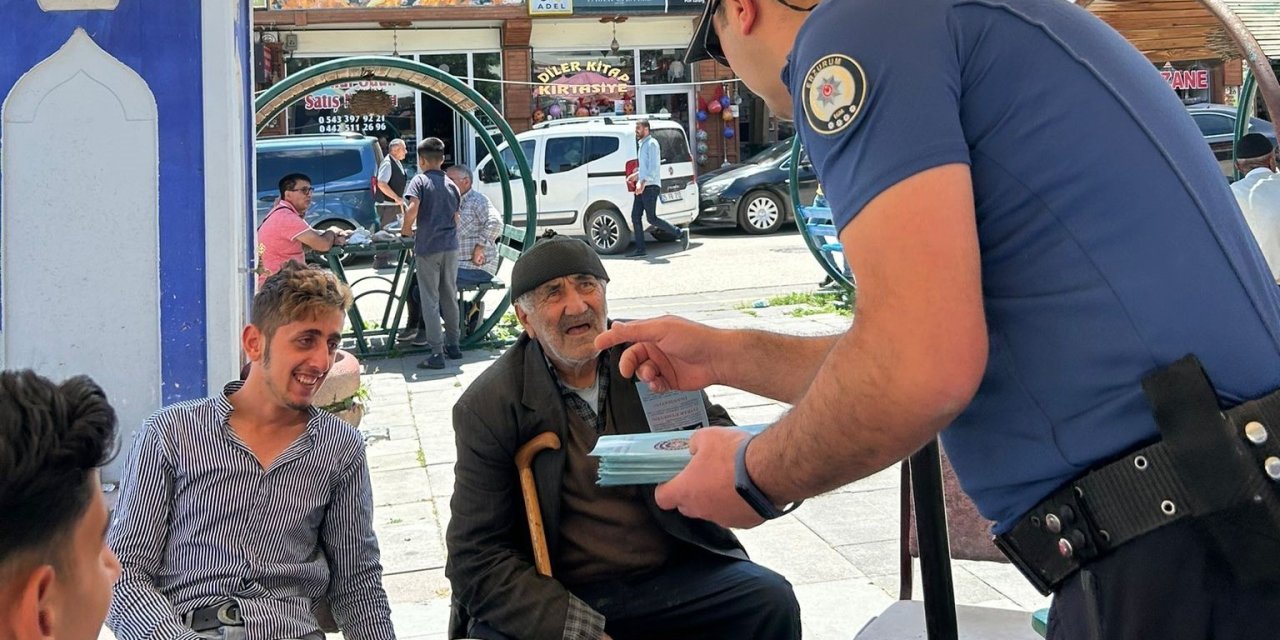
top-left (782, 0), bottom-right (1280, 531)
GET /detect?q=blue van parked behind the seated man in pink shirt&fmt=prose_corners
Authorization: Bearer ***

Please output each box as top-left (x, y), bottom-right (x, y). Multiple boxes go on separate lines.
top-left (256, 133), bottom-right (383, 230)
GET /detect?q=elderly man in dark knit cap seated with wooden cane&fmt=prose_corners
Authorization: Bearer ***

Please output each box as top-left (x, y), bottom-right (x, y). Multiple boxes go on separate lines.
top-left (445, 234), bottom-right (800, 640)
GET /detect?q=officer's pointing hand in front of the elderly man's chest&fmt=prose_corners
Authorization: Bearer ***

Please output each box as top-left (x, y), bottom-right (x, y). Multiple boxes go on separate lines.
top-left (595, 316), bottom-right (724, 393)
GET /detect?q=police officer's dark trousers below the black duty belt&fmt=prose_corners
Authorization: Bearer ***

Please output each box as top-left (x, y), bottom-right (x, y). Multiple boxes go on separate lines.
top-left (1047, 522), bottom-right (1280, 640)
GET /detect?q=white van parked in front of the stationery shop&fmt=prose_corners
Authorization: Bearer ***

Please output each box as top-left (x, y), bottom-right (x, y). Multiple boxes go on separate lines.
top-left (475, 115), bottom-right (698, 255)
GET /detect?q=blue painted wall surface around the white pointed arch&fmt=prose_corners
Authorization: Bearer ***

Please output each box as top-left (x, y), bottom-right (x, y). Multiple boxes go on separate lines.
top-left (0, 0), bottom-right (207, 403)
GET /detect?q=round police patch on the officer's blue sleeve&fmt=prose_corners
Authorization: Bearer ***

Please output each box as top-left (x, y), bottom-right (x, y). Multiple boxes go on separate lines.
top-left (801, 54), bottom-right (867, 136)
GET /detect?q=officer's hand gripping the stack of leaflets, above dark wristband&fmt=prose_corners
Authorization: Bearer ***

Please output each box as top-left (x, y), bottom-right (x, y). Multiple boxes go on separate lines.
top-left (654, 426), bottom-right (764, 529)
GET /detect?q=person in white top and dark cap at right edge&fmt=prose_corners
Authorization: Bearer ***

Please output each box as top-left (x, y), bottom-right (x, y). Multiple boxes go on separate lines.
top-left (1231, 133), bottom-right (1280, 282)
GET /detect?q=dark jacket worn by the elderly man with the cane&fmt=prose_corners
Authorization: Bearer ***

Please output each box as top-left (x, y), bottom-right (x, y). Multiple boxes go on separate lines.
top-left (444, 334), bottom-right (746, 639)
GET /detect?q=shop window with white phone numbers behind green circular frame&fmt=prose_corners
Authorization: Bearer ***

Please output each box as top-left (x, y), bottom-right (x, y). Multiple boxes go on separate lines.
top-left (287, 56), bottom-right (417, 148)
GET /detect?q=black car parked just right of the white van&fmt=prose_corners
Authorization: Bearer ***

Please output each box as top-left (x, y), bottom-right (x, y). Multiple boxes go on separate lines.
top-left (694, 140), bottom-right (818, 233)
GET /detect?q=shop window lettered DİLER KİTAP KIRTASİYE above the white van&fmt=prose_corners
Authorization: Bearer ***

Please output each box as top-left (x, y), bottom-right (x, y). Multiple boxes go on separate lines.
top-left (531, 50), bottom-right (636, 123)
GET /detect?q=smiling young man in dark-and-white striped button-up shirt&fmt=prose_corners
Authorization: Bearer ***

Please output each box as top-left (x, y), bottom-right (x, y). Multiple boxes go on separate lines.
top-left (108, 264), bottom-right (394, 640)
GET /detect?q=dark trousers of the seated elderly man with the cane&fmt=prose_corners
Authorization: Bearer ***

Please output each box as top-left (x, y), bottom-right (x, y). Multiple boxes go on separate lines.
top-left (468, 550), bottom-right (800, 640)
